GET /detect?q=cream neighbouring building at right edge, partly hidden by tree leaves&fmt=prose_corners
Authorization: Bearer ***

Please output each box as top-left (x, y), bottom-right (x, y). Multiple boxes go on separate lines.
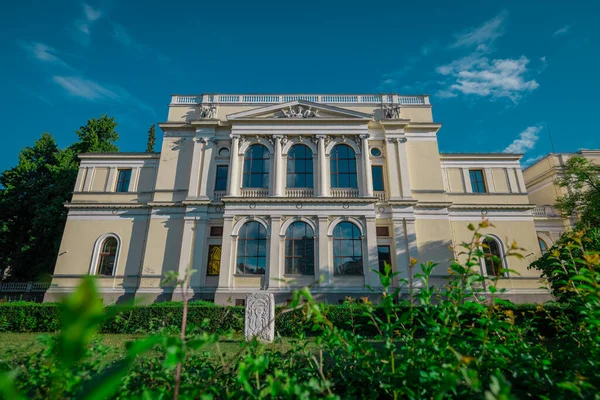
top-left (523, 150), bottom-right (600, 250)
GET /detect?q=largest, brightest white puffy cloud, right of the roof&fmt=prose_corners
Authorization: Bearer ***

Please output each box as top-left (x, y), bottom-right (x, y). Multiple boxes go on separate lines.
top-left (437, 52), bottom-right (539, 102)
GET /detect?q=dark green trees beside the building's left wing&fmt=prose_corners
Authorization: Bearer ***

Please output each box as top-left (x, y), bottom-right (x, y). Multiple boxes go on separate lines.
top-left (0, 115), bottom-right (119, 281)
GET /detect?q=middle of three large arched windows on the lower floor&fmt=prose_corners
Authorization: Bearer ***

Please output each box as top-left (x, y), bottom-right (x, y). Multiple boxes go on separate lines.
top-left (285, 221), bottom-right (315, 275)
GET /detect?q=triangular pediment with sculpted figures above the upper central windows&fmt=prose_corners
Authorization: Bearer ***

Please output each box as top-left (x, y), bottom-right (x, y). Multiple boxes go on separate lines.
top-left (227, 100), bottom-right (373, 120)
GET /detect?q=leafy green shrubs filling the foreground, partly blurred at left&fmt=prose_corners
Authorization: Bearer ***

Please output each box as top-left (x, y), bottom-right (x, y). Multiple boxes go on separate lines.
top-left (0, 221), bottom-right (600, 399)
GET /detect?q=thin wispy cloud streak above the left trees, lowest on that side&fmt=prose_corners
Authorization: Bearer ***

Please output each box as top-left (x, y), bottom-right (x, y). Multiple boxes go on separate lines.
top-left (52, 76), bottom-right (155, 114)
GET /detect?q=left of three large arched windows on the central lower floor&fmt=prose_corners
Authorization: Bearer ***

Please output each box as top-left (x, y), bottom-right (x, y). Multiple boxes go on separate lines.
top-left (237, 221), bottom-right (267, 275)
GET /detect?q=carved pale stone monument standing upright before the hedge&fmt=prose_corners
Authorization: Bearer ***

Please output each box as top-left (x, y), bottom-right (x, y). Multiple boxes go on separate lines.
top-left (244, 293), bottom-right (275, 342)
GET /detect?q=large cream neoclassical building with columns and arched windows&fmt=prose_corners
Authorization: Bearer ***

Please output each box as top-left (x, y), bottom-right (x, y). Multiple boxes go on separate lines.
top-left (46, 94), bottom-right (547, 304)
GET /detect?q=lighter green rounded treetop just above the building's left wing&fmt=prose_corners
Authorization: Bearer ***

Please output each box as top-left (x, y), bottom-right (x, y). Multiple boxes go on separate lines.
top-left (70, 114), bottom-right (119, 154)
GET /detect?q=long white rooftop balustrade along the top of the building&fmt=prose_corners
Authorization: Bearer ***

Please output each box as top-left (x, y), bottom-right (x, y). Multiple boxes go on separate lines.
top-left (171, 94), bottom-right (430, 105)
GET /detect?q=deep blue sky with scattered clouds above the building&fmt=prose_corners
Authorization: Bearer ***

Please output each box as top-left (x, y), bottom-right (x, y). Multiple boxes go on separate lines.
top-left (0, 0), bottom-right (600, 170)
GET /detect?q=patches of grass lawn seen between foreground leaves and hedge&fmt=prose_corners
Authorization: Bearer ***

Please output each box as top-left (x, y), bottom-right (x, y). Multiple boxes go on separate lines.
top-left (0, 333), bottom-right (315, 363)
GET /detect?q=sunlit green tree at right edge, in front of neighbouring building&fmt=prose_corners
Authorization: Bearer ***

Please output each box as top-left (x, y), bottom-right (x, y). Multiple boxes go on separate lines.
top-left (555, 156), bottom-right (600, 226)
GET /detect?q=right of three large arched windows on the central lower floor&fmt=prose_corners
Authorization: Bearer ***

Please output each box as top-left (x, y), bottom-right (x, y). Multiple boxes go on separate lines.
top-left (333, 222), bottom-right (363, 275)
